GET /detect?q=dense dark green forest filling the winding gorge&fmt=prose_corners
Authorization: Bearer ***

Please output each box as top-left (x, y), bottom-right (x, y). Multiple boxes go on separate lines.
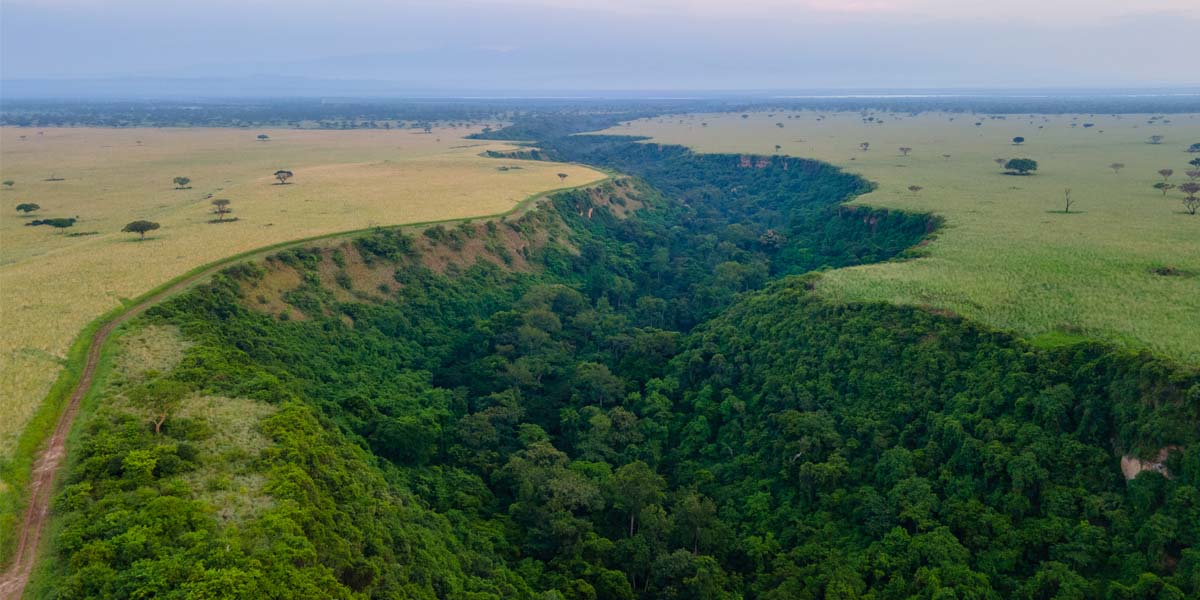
top-left (38, 132), bottom-right (1200, 599)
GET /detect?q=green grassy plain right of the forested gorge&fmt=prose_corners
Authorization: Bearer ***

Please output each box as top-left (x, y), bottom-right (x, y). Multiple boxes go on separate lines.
top-left (608, 112), bottom-right (1200, 365)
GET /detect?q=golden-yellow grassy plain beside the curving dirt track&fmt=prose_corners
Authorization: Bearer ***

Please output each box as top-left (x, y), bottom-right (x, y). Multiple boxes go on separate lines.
top-left (0, 128), bottom-right (604, 460)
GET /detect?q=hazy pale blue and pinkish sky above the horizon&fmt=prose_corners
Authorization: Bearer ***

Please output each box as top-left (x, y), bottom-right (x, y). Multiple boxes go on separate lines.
top-left (0, 0), bottom-right (1200, 94)
